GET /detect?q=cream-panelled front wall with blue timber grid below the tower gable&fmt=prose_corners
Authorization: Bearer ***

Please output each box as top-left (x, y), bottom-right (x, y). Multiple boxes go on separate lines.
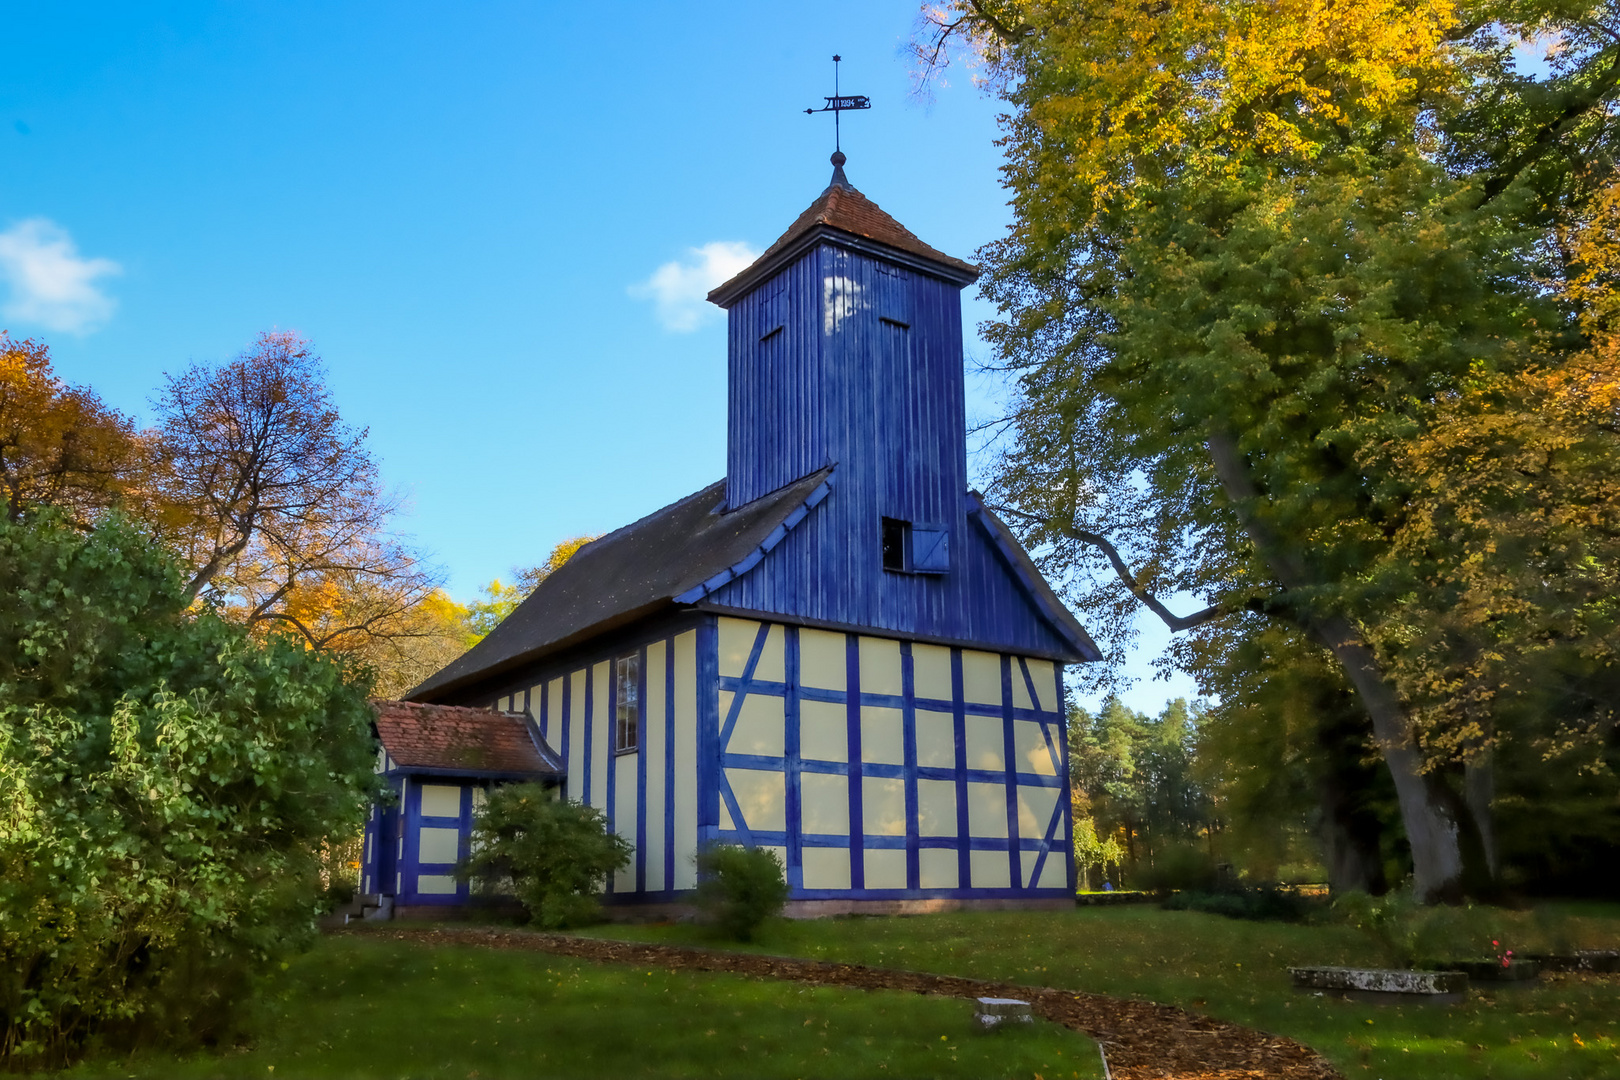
top-left (711, 619), bottom-right (1071, 899)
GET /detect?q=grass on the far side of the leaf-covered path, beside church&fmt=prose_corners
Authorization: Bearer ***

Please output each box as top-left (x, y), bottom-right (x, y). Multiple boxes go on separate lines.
top-left (598, 904), bottom-right (1620, 1080)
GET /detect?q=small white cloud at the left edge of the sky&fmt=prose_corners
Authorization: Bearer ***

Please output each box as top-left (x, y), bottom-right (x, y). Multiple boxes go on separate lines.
top-left (0, 217), bottom-right (123, 334)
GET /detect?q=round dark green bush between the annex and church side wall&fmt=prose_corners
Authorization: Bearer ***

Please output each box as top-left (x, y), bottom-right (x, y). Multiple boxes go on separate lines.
top-left (460, 784), bottom-right (635, 929)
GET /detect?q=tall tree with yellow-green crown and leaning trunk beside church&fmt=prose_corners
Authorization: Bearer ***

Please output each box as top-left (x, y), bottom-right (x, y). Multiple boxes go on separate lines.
top-left (920, 0), bottom-right (1620, 900)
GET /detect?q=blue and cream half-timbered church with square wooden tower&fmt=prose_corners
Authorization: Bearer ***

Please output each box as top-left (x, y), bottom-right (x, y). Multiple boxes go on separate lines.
top-left (390, 154), bottom-right (1098, 915)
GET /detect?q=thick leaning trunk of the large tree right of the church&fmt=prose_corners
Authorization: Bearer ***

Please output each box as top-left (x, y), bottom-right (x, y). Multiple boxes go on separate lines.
top-left (1207, 432), bottom-right (1464, 904)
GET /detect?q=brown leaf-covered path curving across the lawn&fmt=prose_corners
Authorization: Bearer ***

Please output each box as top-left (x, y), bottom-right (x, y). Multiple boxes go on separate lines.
top-left (356, 923), bottom-right (1343, 1080)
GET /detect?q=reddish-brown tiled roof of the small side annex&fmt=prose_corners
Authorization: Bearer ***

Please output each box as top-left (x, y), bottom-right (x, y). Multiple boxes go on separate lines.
top-left (371, 701), bottom-right (564, 779)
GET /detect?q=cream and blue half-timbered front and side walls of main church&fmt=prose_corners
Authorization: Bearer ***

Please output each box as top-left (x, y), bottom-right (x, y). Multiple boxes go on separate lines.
top-left (496, 617), bottom-right (1072, 900)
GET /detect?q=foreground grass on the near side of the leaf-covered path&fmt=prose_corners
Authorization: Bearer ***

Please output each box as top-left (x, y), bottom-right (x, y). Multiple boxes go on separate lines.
top-left (58, 936), bottom-right (1102, 1080)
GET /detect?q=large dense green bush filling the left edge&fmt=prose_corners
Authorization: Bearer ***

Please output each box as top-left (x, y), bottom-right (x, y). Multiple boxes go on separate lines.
top-left (0, 507), bottom-right (373, 1067)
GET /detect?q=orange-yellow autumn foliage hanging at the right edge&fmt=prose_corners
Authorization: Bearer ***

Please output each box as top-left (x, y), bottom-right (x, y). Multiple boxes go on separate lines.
top-left (1369, 181), bottom-right (1620, 767)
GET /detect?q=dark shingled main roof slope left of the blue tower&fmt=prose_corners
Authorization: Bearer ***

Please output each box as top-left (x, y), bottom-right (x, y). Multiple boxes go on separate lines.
top-left (405, 468), bottom-right (833, 701)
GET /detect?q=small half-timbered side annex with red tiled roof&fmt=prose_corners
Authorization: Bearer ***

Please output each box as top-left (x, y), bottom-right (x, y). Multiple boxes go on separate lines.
top-left (360, 701), bottom-right (562, 916)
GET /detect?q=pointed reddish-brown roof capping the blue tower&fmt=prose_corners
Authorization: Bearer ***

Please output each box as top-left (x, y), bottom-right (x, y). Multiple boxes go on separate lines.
top-left (708, 154), bottom-right (978, 308)
